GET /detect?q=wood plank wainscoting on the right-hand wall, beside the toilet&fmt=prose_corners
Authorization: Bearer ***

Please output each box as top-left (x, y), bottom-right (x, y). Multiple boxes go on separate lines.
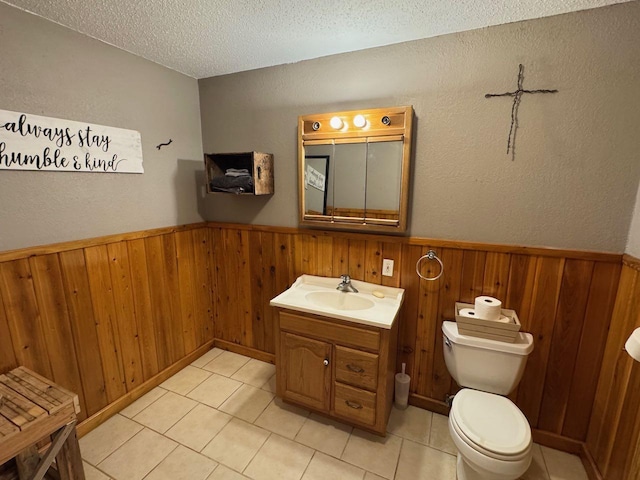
top-left (586, 255), bottom-right (640, 480)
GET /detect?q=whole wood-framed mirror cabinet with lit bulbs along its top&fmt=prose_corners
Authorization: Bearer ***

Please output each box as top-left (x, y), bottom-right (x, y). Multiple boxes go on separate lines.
top-left (298, 107), bottom-right (413, 233)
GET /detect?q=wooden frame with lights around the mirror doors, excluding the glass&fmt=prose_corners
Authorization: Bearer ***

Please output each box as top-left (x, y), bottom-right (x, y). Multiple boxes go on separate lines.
top-left (298, 106), bottom-right (413, 233)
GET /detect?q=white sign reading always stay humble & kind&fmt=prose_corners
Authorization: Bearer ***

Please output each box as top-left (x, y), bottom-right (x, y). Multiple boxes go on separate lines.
top-left (0, 110), bottom-right (144, 173)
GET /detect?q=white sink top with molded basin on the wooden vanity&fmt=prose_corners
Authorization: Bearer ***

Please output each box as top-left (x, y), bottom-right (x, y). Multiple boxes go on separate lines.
top-left (270, 275), bottom-right (404, 328)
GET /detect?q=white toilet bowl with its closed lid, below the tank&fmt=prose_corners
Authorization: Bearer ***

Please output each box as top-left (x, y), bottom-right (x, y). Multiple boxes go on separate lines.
top-left (449, 389), bottom-right (532, 480)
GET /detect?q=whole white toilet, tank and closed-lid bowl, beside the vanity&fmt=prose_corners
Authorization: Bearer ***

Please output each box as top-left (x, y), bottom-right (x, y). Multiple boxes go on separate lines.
top-left (442, 322), bottom-right (533, 480)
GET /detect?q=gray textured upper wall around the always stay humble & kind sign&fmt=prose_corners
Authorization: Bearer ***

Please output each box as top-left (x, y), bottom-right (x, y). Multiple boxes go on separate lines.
top-left (0, 3), bottom-right (203, 251)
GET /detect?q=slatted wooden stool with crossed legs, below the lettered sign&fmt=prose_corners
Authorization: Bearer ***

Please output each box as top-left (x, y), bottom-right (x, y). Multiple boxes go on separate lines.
top-left (0, 367), bottom-right (84, 480)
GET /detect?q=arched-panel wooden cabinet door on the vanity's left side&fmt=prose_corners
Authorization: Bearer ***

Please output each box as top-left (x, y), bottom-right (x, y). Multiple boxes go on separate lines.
top-left (280, 332), bottom-right (331, 411)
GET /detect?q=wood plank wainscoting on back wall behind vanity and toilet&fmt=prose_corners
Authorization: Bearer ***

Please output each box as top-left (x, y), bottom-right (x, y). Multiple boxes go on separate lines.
top-left (211, 224), bottom-right (621, 448)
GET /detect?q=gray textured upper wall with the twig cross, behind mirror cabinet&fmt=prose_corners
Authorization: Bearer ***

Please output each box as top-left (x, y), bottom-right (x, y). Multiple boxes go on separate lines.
top-left (199, 2), bottom-right (640, 252)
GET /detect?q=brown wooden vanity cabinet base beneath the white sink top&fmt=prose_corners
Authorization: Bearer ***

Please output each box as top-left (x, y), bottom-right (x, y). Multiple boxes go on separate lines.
top-left (276, 309), bottom-right (398, 435)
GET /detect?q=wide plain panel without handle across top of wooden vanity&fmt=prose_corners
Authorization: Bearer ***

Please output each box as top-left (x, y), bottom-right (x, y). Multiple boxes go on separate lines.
top-left (280, 311), bottom-right (380, 351)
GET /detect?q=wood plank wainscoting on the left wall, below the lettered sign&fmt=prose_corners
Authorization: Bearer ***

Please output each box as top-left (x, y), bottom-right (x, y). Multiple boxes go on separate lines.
top-left (0, 224), bottom-right (213, 419)
